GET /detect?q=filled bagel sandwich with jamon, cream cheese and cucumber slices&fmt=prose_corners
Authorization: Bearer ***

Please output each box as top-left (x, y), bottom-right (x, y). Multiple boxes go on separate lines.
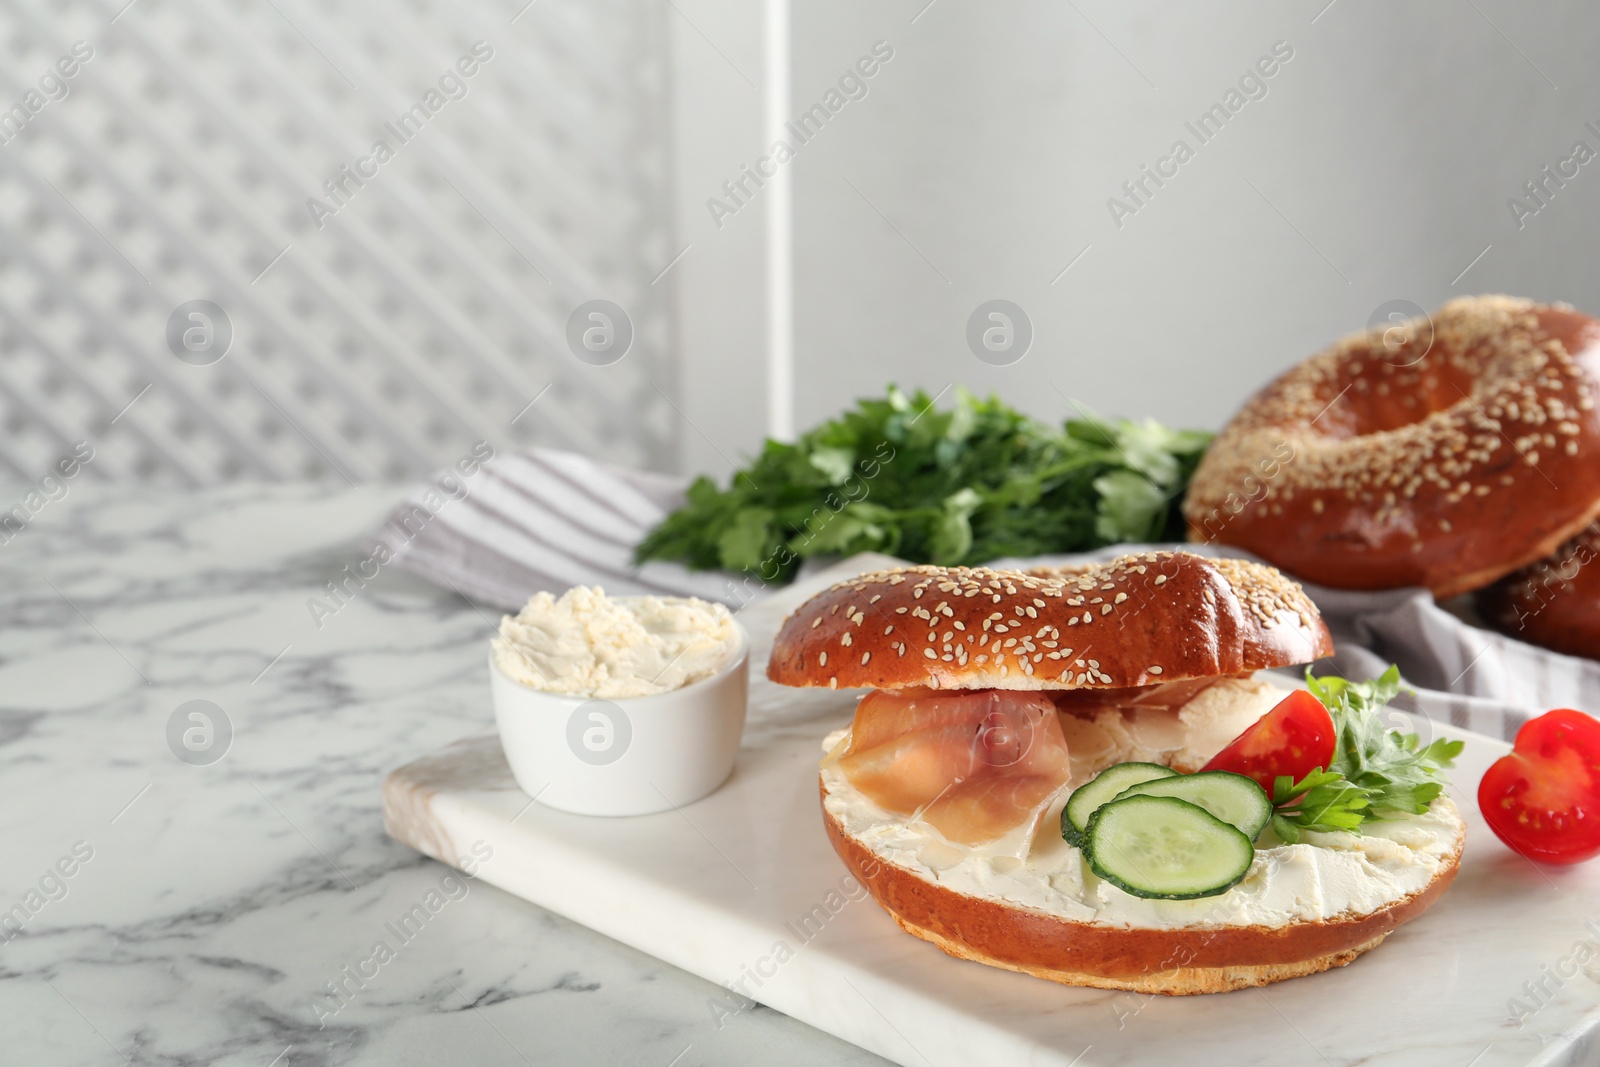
top-left (766, 552), bottom-right (1464, 995)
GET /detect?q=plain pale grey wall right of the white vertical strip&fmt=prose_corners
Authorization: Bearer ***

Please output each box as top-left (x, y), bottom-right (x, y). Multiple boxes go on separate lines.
top-left (685, 0), bottom-right (1600, 460)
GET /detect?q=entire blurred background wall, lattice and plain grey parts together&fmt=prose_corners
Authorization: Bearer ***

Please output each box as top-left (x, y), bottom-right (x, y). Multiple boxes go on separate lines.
top-left (0, 0), bottom-right (1600, 483)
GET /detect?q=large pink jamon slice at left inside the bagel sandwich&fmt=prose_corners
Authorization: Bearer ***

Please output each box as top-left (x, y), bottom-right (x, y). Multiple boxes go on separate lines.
top-left (838, 689), bottom-right (1070, 845)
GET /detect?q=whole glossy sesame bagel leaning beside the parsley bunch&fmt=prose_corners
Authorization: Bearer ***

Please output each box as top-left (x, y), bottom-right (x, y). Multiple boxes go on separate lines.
top-left (1184, 296), bottom-right (1600, 598)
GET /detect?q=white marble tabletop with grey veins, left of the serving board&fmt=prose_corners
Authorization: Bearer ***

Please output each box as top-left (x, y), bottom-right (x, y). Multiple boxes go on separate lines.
top-left (0, 483), bottom-right (882, 1067)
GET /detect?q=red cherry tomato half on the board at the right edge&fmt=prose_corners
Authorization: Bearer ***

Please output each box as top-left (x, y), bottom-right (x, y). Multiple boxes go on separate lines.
top-left (1478, 709), bottom-right (1600, 864)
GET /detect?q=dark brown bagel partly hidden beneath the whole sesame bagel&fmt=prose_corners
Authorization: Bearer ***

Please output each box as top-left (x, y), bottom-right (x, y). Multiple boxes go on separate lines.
top-left (1474, 523), bottom-right (1600, 659)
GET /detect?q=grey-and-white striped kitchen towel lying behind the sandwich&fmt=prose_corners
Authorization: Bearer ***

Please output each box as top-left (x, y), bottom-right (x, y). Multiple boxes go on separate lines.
top-left (374, 448), bottom-right (1600, 737)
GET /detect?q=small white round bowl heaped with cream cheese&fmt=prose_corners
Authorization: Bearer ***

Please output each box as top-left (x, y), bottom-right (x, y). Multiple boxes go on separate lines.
top-left (490, 585), bottom-right (749, 816)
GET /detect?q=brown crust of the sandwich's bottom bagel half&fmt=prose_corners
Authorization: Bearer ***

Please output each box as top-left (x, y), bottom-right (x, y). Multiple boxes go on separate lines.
top-left (819, 781), bottom-right (1462, 997)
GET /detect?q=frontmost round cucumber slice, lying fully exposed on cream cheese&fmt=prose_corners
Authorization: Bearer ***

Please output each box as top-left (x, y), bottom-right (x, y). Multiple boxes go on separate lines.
top-left (1086, 797), bottom-right (1256, 901)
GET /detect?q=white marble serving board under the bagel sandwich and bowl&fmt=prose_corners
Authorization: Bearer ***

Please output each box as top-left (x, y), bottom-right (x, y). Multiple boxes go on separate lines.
top-left (384, 557), bottom-right (1600, 1067)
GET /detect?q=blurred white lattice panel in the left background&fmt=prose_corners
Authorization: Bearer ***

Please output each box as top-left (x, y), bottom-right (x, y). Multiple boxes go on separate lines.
top-left (0, 0), bottom-right (678, 485)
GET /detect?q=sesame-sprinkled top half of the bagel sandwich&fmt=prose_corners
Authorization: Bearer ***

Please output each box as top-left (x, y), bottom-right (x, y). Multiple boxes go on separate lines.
top-left (766, 552), bottom-right (1333, 689)
